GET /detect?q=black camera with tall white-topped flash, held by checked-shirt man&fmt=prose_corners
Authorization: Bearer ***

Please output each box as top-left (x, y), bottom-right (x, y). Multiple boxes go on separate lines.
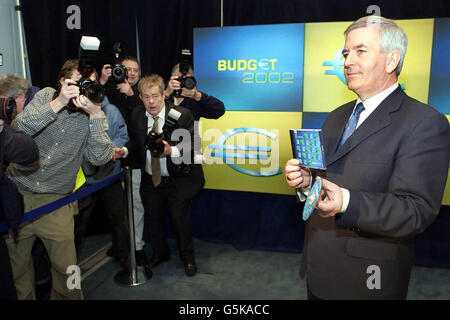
top-left (67, 36), bottom-right (105, 110)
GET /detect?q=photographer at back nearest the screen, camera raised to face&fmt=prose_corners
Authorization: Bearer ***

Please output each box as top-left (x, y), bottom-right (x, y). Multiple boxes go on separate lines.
top-left (164, 63), bottom-right (225, 120)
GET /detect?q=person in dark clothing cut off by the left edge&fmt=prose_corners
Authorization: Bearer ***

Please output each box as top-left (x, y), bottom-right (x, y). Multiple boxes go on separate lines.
top-left (0, 119), bottom-right (39, 300)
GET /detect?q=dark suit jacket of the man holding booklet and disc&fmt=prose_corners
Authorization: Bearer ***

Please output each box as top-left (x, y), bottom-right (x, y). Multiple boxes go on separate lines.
top-left (301, 88), bottom-right (450, 299)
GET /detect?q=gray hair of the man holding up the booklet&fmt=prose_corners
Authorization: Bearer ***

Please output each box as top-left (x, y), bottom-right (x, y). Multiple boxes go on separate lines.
top-left (344, 16), bottom-right (408, 76)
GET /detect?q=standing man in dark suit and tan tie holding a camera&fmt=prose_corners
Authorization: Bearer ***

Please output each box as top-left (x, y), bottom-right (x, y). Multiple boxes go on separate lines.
top-left (118, 75), bottom-right (205, 276)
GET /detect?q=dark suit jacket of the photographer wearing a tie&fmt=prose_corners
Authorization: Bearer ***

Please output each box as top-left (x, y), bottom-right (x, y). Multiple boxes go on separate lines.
top-left (126, 100), bottom-right (205, 198)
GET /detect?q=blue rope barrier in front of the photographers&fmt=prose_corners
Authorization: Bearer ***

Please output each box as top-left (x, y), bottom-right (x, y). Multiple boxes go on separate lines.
top-left (0, 171), bottom-right (123, 232)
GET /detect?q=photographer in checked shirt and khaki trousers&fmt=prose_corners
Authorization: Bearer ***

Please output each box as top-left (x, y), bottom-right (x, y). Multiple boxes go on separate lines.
top-left (5, 60), bottom-right (113, 299)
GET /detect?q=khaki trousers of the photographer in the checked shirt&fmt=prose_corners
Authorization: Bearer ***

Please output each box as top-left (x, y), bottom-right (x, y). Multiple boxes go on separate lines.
top-left (5, 191), bottom-right (83, 300)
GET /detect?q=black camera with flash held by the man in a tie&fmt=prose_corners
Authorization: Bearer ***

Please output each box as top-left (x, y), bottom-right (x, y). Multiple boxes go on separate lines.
top-left (145, 109), bottom-right (181, 157)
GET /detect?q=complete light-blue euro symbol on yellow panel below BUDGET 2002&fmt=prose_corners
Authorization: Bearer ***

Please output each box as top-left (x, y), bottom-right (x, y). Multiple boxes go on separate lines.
top-left (208, 127), bottom-right (281, 177)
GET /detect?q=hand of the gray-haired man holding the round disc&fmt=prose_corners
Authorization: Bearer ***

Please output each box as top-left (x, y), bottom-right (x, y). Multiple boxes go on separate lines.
top-left (315, 179), bottom-right (344, 218)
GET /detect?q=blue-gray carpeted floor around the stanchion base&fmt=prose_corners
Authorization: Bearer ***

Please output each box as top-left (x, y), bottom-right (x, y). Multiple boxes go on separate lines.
top-left (79, 234), bottom-right (450, 300)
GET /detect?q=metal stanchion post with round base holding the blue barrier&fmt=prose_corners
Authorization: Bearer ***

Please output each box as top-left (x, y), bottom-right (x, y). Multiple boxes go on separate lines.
top-left (114, 166), bottom-right (152, 286)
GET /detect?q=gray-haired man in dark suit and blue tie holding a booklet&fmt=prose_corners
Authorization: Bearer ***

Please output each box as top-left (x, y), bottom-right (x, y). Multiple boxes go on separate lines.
top-left (285, 17), bottom-right (450, 299)
